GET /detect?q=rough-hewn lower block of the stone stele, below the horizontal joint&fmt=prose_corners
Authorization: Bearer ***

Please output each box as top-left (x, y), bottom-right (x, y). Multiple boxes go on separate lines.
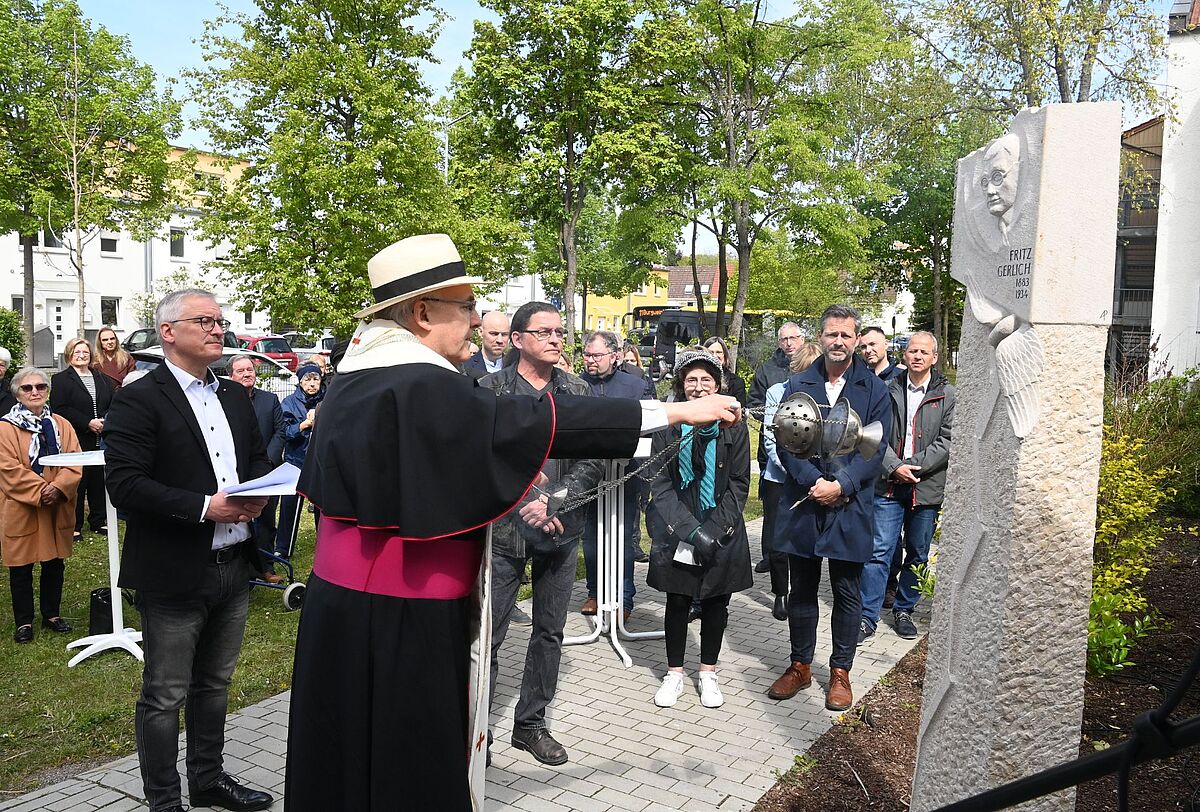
top-left (912, 319), bottom-right (1108, 812)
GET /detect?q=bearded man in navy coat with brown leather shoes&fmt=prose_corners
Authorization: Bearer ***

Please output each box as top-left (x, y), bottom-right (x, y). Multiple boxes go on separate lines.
top-left (767, 305), bottom-right (892, 710)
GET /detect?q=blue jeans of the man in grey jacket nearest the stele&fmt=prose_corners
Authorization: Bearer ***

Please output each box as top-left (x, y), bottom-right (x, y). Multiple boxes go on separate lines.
top-left (862, 492), bottom-right (942, 628)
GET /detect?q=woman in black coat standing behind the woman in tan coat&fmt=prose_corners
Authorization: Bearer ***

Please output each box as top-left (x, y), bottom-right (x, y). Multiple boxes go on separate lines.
top-left (50, 338), bottom-right (113, 541)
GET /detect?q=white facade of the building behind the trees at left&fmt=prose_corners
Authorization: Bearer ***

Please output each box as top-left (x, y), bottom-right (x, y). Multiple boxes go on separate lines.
top-left (0, 212), bottom-right (270, 362)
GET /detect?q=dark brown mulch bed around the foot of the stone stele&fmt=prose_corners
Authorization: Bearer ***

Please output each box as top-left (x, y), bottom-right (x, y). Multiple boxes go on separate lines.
top-left (755, 534), bottom-right (1200, 812)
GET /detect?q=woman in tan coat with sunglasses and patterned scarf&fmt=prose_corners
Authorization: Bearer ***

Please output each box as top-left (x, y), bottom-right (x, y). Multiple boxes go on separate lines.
top-left (0, 369), bottom-right (83, 643)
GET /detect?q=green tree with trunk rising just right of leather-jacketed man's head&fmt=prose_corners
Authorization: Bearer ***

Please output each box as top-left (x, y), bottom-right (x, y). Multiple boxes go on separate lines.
top-left (469, 0), bottom-right (666, 330)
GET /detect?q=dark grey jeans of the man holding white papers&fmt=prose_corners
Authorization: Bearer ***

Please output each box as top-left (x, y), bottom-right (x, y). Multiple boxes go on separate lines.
top-left (134, 555), bottom-right (252, 812)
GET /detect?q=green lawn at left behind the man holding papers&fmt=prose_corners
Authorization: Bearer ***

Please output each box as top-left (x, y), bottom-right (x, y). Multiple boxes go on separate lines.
top-left (0, 512), bottom-right (314, 804)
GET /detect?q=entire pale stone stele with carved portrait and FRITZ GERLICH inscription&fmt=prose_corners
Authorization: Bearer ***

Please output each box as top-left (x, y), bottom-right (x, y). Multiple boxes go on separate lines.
top-left (912, 102), bottom-right (1121, 811)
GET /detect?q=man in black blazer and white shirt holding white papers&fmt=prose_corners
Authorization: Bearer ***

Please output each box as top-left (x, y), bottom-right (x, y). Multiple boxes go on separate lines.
top-left (104, 290), bottom-right (274, 812)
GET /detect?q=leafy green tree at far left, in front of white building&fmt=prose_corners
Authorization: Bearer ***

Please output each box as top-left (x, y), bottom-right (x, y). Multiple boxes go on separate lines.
top-left (0, 0), bottom-right (186, 343)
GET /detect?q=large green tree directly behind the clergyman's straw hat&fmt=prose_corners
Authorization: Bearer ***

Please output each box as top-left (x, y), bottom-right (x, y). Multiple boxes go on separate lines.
top-left (190, 0), bottom-right (463, 330)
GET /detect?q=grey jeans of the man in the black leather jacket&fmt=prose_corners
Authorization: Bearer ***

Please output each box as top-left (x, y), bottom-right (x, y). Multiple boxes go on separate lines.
top-left (491, 541), bottom-right (578, 729)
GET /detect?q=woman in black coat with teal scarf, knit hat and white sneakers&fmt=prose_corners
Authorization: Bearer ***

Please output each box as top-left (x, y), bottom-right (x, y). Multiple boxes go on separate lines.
top-left (646, 349), bottom-right (754, 708)
